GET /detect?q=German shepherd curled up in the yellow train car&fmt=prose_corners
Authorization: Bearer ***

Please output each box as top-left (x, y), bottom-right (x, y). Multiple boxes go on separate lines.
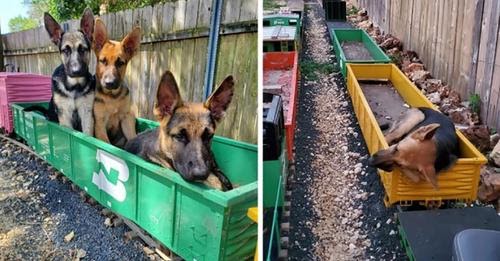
top-left (369, 108), bottom-right (459, 190)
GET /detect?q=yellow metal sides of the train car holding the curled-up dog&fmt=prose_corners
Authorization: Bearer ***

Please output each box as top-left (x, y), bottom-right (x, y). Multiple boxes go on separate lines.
top-left (347, 64), bottom-right (486, 206)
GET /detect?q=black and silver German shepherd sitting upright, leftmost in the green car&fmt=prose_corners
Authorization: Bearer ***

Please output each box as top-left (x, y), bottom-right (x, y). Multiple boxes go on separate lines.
top-left (43, 8), bottom-right (95, 136)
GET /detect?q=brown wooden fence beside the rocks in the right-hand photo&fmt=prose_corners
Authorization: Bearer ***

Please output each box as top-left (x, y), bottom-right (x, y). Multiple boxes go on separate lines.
top-left (352, 0), bottom-right (500, 130)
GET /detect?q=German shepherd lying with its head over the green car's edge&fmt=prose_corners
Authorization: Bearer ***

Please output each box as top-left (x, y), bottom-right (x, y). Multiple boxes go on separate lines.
top-left (125, 71), bottom-right (234, 191)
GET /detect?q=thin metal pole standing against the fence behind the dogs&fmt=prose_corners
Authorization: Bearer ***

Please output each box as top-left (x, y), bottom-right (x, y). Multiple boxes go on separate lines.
top-left (204, 0), bottom-right (224, 99)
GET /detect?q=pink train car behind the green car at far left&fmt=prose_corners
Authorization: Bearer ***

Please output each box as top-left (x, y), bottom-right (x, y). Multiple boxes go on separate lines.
top-left (0, 72), bottom-right (51, 134)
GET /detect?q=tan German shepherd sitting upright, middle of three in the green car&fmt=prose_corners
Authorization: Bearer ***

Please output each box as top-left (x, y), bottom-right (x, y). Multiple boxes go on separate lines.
top-left (94, 18), bottom-right (141, 147)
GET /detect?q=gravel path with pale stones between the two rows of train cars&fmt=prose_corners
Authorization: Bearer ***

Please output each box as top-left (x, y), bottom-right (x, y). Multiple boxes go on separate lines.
top-left (288, 1), bottom-right (405, 260)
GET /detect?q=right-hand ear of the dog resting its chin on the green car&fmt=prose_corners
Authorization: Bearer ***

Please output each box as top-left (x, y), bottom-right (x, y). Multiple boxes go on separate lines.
top-left (205, 75), bottom-right (234, 121)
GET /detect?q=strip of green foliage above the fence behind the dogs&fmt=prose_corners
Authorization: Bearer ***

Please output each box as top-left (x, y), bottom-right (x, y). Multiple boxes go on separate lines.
top-left (30, 0), bottom-right (172, 21)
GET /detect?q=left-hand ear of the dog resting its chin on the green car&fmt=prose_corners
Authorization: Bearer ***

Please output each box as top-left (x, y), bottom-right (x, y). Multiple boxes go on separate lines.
top-left (154, 71), bottom-right (182, 120)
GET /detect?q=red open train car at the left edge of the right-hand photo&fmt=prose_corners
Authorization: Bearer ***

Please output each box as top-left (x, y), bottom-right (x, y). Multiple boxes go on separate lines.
top-left (263, 52), bottom-right (299, 160)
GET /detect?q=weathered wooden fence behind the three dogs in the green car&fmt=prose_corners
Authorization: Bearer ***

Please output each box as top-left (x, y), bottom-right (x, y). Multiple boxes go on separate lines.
top-left (2, 0), bottom-right (258, 143)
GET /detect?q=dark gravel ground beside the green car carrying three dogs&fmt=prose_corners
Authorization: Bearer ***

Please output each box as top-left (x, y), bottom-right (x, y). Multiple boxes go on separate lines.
top-left (0, 138), bottom-right (147, 260)
